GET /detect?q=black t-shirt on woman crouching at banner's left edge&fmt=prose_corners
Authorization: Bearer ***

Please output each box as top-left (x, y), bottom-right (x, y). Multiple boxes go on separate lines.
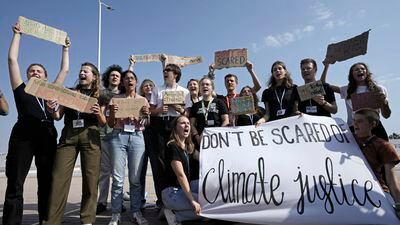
top-left (162, 143), bottom-right (190, 189)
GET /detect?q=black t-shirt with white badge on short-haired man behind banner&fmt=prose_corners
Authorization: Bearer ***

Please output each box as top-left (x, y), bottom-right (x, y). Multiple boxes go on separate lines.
top-left (299, 83), bottom-right (336, 117)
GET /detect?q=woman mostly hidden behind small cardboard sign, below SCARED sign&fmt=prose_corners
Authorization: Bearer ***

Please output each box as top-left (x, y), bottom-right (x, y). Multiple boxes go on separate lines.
top-left (235, 86), bottom-right (265, 126)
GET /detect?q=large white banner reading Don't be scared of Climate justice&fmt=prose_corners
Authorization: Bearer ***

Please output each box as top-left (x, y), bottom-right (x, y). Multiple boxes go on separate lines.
top-left (199, 115), bottom-right (400, 225)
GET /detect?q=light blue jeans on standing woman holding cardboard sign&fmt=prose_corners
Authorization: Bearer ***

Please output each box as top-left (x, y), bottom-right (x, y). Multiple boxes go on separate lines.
top-left (110, 130), bottom-right (144, 213)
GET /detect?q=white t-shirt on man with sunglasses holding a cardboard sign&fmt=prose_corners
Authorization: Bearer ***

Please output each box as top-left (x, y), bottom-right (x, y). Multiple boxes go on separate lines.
top-left (150, 84), bottom-right (192, 117)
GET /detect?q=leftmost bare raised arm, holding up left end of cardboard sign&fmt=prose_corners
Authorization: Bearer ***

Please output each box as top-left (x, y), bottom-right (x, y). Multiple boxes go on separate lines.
top-left (8, 23), bottom-right (23, 90)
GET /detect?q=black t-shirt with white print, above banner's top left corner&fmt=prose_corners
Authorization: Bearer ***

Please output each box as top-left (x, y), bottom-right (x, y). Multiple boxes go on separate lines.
top-left (190, 98), bottom-right (228, 134)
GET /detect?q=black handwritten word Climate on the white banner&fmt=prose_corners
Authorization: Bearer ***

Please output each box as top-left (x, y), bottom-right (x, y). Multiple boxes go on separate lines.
top-left (202, 157), bottom-right (284, 206)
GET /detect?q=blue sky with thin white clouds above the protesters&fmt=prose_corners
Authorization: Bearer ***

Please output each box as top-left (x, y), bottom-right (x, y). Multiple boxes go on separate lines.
top-left (0, 0), bottom-right (400, 153)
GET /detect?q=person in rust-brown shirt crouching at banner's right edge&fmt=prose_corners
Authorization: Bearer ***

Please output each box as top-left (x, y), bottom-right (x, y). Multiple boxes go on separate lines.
top-left (354, 108), bottom-right (400, 216)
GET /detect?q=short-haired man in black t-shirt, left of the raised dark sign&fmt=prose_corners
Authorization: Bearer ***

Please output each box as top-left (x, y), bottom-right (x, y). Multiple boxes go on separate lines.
top-left (299, 58), bottom-right (337, 117)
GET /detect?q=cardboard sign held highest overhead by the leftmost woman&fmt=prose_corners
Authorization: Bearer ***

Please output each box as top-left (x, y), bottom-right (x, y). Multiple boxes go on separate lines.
top-left (18, 16), bottom-right (67, 45)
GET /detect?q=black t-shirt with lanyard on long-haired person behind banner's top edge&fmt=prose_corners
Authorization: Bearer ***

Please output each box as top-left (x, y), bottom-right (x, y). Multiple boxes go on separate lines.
top-left (261, 85), bottom-right (299, 121)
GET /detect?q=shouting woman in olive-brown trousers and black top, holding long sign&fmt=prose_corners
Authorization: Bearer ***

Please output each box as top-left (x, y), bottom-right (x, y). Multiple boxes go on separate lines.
top-left (45, 62), bottom-right (106, 225)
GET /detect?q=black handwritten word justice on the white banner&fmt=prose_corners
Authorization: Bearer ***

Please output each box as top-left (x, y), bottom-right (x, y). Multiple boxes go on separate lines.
top-left (294, 157), bottom-right (381, 214)
